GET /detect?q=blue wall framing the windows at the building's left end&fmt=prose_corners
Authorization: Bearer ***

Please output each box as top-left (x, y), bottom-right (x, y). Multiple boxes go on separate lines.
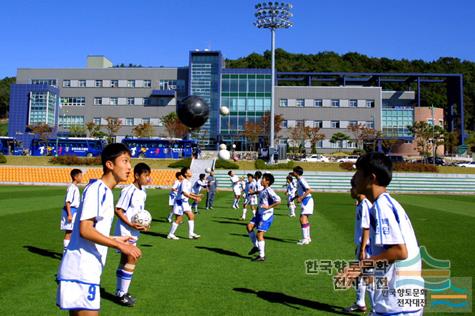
top-left (8, 84), bottom-right (59, 149)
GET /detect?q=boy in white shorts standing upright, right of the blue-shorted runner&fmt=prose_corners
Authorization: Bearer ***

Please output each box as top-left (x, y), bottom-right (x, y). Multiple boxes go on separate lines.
top-left (293, 166), bottom-right (313, 246)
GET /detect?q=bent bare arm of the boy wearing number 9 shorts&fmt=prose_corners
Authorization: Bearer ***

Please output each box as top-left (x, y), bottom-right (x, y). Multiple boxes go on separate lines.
top-left (79, 218), bottom-right (142, 259)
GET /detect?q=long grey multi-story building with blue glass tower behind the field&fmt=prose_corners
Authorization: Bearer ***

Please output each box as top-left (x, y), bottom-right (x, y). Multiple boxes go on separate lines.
top-left (9, 50), bottom-right (464, 154)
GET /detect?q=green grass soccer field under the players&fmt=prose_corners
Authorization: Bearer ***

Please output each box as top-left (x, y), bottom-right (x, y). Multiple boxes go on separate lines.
top-left (0, 186), bottom-right (475, 315)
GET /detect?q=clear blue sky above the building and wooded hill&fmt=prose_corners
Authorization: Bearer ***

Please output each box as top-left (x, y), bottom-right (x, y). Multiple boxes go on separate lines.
top-left (0, 0), bottom-right (475, 78)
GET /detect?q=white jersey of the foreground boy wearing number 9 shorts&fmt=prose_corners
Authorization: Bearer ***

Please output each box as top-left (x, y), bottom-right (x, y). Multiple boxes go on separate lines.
top-left (58, 180), bottom-right (114, 284)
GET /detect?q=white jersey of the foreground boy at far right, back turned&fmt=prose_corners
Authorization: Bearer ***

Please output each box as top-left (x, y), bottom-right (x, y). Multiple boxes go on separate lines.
top-left (369, 193), bottom-right (424, 313)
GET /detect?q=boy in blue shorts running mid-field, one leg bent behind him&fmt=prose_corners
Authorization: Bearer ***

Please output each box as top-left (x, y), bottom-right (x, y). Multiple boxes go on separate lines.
top-left (247, 173), bottom-right (280, 261)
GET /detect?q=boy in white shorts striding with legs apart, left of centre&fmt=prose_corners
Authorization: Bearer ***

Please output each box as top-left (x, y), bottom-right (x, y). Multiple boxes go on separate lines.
top-left (167, 167), bottom-right (201, 240)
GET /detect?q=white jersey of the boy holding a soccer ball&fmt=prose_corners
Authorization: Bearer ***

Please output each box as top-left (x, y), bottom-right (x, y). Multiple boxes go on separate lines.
top-left (115, 183), bottom-right (147, 236)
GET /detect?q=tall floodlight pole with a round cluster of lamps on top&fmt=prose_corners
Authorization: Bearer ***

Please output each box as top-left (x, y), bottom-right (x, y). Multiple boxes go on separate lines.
top-left (254, 2), bottom-right (293, 163)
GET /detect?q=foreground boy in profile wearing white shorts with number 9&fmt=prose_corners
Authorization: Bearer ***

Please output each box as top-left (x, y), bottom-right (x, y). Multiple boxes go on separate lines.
top-left (56, 143), bottom-right (141, 315)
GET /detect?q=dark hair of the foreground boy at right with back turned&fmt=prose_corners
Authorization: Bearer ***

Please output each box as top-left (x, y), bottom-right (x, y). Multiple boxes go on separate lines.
top-left (356, 152), bottom-right (393, 187)
